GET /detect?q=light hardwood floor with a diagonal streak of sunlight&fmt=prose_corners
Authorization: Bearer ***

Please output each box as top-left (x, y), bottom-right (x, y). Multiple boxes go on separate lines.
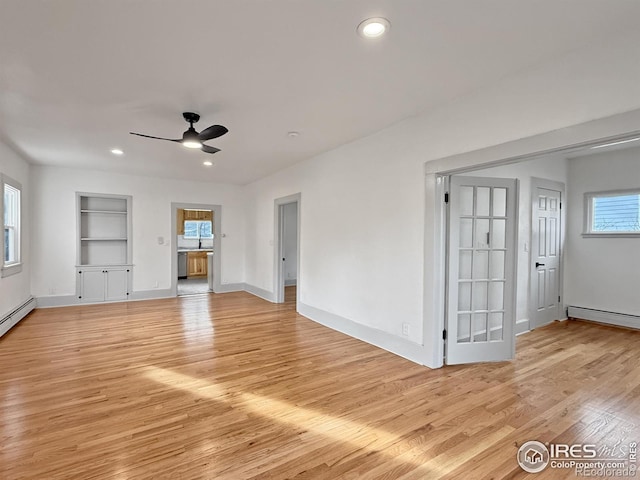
top-left (0, 289), bottom-right (640, 480)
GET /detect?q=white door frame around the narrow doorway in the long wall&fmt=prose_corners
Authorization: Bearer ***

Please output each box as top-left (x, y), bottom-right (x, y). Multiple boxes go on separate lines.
top-left (273, 193), bottom-right (302, 302)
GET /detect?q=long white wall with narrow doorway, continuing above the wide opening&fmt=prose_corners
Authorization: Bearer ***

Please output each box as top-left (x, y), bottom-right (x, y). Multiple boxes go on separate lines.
top-left (241, 32), bottom-right (640, 366)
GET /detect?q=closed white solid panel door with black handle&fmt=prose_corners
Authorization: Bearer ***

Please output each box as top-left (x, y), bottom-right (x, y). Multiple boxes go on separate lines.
top-left (531, 182), bottom-right (562, 328)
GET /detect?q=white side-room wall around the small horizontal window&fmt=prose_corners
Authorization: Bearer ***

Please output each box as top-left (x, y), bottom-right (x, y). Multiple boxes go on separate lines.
top-left (565, 148), bottom-right (640, 315)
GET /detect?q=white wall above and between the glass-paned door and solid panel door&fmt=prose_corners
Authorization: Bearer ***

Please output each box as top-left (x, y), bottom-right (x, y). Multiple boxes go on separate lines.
top-left (467, 155), bottom-right (569, 329)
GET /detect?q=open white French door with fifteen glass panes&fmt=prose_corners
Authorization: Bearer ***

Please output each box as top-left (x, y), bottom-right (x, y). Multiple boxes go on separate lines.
top-left (446, 176), bottom-right (517, 365)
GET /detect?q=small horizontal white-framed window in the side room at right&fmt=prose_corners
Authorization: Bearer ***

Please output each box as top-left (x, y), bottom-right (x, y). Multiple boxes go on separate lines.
top-left (585, 189), bottom-right (640, 236)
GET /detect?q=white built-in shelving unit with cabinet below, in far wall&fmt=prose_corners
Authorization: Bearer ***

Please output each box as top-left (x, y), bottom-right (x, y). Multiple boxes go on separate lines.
top-left (76, 193), bottom-right (132, 302)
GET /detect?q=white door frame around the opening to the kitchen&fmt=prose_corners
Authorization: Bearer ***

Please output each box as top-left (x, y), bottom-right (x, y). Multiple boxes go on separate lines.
top-left (170, 202), bottom-right (223, 297)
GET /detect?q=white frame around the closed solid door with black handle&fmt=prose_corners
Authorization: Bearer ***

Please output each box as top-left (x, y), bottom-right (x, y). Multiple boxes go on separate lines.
top-left (528, 177), bottom-right (567, 330)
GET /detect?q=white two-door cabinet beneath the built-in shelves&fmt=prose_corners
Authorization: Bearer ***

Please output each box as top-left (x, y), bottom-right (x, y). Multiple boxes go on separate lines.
top-left (76, 265), bottom-right (132, 303)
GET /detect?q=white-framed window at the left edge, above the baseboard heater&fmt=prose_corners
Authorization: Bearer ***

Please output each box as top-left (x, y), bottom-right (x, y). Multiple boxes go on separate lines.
top-left (2, 176), bottom-right (22, 277)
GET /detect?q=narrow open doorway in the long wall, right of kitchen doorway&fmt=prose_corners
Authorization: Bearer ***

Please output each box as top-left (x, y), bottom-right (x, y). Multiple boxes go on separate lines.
top-left (274, 194), bottom-right (300, 305)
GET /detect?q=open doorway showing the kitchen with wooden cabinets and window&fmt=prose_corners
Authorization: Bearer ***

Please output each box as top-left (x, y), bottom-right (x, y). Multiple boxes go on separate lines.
top-left (171, 203), bottom-right (220, 296)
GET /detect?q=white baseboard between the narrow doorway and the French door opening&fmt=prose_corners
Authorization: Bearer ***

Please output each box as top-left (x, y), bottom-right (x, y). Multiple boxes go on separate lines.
top-left (298, 302), bottom-right (430, 368)
